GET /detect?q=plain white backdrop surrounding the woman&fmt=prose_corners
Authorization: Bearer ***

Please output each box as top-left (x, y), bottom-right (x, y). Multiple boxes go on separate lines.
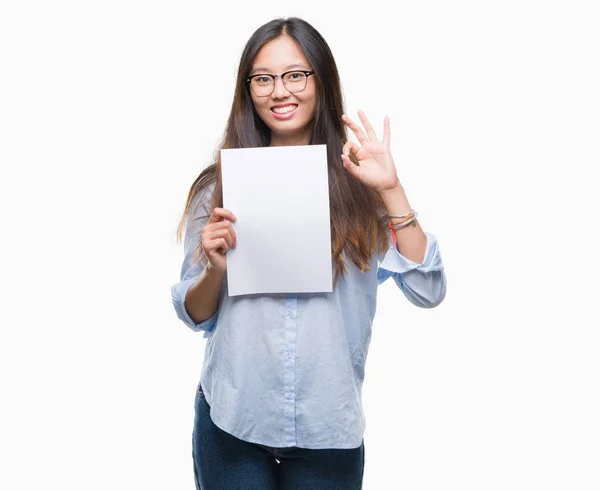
top-left (0, 0), bottom-right (600, 490)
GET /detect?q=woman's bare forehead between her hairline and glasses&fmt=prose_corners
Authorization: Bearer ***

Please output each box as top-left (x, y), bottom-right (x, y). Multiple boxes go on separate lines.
top-left (252, 36), bottom-right (311, 73)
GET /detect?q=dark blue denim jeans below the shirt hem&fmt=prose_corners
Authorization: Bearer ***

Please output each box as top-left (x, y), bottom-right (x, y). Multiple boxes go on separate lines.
top-left (192, 385), bottom-right (365, 490)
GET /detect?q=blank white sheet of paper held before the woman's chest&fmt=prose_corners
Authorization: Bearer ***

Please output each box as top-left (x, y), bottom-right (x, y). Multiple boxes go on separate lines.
top-left (221, 145), bottom-right (332, 296)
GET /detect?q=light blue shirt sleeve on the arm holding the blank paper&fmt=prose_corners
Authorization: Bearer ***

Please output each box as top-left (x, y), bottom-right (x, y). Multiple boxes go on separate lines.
top-left (171, 184), bottom-right (219, 338)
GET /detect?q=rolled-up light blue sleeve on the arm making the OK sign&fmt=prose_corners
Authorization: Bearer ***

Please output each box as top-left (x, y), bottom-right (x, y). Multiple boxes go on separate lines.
top-left (377, 232), bottom-right (446, 308)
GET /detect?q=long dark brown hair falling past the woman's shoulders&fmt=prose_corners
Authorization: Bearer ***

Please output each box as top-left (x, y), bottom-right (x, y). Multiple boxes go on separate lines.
top-left (177, 17), bottom-right (389, 284)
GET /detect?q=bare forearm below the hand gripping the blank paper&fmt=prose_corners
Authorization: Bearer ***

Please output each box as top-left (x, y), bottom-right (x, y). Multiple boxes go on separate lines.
top-left (185, 266), bottom-right (226, 323)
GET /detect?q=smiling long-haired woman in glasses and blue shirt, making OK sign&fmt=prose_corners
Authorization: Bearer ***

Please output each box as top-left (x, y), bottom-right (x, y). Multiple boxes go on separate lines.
top-left (172, 18), bottom-right (446, 490)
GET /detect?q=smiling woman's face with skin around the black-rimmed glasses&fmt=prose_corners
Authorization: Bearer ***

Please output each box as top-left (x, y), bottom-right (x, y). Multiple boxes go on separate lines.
top-left (248, 36), bottom-right (317, 146)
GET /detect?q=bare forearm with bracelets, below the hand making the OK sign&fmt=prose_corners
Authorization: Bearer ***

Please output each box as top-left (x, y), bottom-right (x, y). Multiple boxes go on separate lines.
top-left (380, 181), bottom-right (427, 264)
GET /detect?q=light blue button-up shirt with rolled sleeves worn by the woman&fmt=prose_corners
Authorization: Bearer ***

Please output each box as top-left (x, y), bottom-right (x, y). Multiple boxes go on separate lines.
top-left (171, 184), bottom-right (446, 449)
